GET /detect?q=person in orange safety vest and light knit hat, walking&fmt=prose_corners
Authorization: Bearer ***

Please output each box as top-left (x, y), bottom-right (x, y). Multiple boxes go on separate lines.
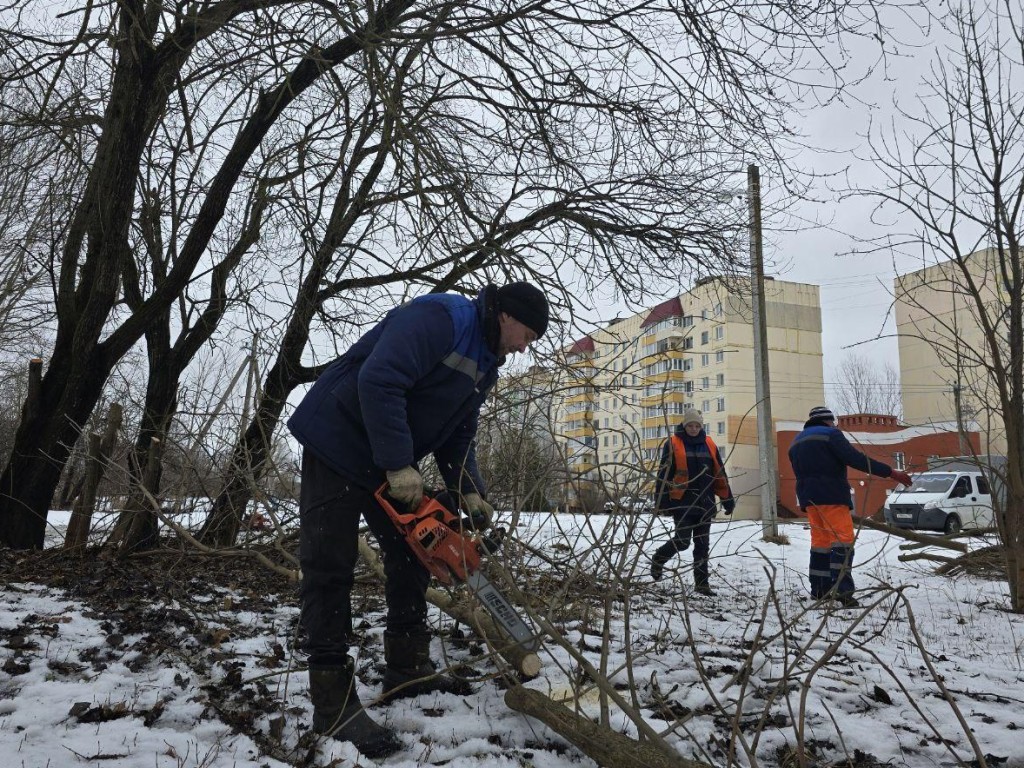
top-left (650, 409), bottom-right (736, 595)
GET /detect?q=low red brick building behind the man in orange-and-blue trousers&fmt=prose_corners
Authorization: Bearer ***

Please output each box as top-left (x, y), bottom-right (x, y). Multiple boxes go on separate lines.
top-left (775, 414), bottom-right (981, 517)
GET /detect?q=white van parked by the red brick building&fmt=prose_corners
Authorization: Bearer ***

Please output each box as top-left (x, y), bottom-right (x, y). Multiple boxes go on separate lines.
top-left (885, 471), bottom-right (995, 534)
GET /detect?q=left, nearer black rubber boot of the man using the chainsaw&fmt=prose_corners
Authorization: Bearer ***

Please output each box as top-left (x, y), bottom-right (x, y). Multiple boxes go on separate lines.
top-left (309, 658), bottom-right (403, 758)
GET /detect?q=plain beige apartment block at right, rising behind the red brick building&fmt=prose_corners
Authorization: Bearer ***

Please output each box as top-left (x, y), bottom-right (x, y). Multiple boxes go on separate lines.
top-left (893, 249), bottom-right (1007, 455)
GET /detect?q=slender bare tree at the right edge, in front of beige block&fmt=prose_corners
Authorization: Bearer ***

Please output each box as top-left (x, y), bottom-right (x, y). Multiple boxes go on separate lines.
top-left (871, 2), bottom-right (1024, 612)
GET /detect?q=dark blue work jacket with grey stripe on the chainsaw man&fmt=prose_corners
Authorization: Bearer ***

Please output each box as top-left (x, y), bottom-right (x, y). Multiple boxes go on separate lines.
top-left (288, 289), bottom-right (504, 495)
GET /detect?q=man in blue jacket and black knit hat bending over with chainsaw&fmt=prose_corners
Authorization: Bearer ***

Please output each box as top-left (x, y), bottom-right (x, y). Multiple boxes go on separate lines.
top-left (288, 283), bottom-right (548, 757)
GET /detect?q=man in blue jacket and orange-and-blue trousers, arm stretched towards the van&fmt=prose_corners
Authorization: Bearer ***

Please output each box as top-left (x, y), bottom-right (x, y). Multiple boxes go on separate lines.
top-left (790, 406), bottom-right (912, 608)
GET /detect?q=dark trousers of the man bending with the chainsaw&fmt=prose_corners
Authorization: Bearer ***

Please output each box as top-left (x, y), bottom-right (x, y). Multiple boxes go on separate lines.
top-left (299, 451), bottom-right (430, 667)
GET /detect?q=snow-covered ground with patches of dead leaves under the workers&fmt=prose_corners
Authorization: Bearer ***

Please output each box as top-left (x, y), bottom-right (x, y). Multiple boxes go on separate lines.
top-left (0, 513), bottom-right (1024, 768)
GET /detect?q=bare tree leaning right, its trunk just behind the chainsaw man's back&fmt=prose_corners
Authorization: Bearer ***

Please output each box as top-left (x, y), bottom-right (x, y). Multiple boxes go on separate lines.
top-left (192, 3), bottom-right (921, 544)
